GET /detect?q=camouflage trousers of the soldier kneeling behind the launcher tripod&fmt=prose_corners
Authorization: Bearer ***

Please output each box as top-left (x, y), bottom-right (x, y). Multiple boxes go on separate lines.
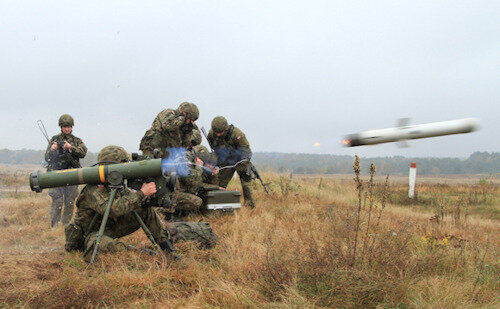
top-left (83, 207), bottom-right (168, 257)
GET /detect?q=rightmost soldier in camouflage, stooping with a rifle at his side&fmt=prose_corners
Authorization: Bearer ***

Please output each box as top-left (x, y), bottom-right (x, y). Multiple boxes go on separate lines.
top-left (207, 116), bottom-right (255, 208)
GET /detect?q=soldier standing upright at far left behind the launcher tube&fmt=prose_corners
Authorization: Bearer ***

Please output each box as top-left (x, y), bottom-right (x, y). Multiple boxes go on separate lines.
top-left (45, 114), bottom-right (87, 227)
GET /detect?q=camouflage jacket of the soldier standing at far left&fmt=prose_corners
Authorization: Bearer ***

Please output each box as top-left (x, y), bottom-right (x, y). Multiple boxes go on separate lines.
top-left (45, 133), bottom-right (87, 171)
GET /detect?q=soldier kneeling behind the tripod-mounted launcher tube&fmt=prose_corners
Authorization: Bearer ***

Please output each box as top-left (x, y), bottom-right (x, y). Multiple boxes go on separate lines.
top-left (65, 145), bottom-right (174, 252)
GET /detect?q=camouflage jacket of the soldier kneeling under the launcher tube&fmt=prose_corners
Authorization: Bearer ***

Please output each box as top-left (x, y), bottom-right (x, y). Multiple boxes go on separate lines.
top-left (75, 185), bottom-right (145, 231)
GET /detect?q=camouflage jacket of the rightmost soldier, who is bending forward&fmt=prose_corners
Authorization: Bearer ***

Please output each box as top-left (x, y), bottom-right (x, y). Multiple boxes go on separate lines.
top-left (207, 125), bottom-right (252, 168)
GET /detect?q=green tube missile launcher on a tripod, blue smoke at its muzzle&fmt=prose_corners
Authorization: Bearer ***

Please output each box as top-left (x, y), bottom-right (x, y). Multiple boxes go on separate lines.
top-left (30, 150), bottom-right (241, 264)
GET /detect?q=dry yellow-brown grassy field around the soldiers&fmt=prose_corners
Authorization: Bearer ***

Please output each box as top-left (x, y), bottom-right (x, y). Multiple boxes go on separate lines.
top-left (0, 160), bottom-right (500, 308)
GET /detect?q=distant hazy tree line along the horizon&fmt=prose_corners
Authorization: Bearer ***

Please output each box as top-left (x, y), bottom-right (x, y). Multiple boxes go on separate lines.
top-left (0, 149), bottom-right (500, 175)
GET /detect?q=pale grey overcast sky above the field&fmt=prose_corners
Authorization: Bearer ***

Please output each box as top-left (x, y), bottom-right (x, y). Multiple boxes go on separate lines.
top-left (0, 0), bottom-right (500, 157)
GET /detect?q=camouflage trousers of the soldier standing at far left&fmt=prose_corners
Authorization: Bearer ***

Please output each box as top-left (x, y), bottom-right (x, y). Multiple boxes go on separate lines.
top-left (49, 186), bottom-right (78, 227)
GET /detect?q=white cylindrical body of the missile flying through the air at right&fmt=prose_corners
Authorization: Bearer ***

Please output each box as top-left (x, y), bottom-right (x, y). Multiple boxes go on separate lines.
top-left (342, 118), bottom-right (479, 147)
